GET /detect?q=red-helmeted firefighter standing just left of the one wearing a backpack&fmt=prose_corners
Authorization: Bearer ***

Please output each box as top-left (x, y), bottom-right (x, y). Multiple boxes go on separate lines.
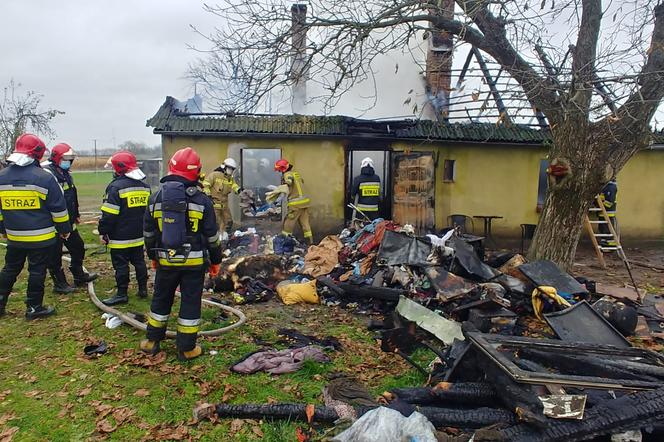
top-left (99, 151), bottom-right (150, 306)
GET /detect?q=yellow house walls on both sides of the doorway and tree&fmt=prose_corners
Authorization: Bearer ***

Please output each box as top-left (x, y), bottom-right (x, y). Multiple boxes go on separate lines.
top-left (162, 136), bottom-right (664, 239)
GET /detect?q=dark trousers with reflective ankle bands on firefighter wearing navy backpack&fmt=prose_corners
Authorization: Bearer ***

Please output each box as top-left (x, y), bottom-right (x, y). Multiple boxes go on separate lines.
top-left (147, 267), bottom-right (205, 351)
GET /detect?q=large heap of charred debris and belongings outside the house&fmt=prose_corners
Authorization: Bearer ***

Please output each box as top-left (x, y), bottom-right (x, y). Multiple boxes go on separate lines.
top-left (199, 219), bottom-right (664, 441)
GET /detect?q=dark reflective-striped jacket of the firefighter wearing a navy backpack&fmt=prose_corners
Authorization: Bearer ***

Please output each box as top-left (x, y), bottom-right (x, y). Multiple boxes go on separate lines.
top-left (143, 175), bottom-right (222, 270)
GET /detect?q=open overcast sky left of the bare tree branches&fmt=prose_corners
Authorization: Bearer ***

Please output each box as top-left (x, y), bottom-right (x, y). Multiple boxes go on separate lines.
top-left (0, 0), bottom-right (213, 150)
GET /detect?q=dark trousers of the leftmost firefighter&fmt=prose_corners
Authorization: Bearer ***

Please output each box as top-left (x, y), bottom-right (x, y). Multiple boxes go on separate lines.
top-left (0, 246), bottom-right (53, 307)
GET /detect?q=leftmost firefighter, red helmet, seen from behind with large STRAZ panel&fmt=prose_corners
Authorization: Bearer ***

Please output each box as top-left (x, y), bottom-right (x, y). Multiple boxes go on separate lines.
top-left (0, 134), bottom-right (71, 320)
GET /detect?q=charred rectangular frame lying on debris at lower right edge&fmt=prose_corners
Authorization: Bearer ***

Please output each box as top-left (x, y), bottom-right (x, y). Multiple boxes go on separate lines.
top-left (465, 332), bottom-right (664, 390)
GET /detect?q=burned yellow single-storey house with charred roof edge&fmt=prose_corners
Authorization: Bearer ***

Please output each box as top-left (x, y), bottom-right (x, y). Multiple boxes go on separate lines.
top-left (147, 97), bottom-right (664, 239)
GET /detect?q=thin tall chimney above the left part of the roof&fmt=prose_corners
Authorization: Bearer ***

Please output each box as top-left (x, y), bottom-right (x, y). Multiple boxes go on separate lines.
top-left (291, 3), bottom-right (309, 114)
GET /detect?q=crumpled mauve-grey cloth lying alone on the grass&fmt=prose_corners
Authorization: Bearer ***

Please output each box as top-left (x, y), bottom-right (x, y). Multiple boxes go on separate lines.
top-left (231, 345), bottom-right (330, 374)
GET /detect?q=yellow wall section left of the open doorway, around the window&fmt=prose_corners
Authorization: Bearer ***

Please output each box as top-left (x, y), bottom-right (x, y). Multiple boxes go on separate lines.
top-left (162, 136), bottom-right (344, 238)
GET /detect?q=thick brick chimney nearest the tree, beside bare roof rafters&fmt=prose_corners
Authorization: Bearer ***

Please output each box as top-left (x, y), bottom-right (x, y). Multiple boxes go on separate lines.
top-left (426, 0), bottom-right (454, 120)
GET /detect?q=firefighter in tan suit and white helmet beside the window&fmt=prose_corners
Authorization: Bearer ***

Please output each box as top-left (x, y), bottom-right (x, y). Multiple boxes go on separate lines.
top-left (203, 158), bottom-right (242, 235)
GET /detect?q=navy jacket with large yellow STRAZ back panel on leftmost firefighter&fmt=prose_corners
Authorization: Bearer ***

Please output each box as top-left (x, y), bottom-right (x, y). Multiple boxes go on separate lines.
top-left (0, 161), bottom-right (71, 249)
